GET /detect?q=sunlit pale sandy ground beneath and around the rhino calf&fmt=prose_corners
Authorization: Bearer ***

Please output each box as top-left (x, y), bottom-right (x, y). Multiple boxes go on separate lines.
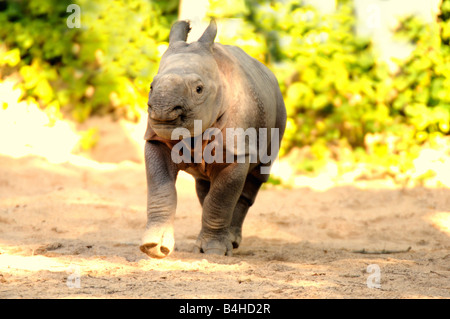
top-left (0, 113), bottom-right (450, 299)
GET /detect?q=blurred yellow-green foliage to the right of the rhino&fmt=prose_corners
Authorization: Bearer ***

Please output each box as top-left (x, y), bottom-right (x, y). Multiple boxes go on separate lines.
top-left (210, 0), bottom-right (450, 178)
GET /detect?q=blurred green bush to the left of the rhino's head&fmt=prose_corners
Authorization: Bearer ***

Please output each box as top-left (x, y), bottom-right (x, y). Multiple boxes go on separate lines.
top-left (0, 0), bottom-right (178, 121)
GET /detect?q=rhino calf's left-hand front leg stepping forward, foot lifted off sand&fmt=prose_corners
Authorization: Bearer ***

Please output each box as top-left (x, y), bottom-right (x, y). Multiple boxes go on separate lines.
top-left (140, 141), bottom-right (178, 258)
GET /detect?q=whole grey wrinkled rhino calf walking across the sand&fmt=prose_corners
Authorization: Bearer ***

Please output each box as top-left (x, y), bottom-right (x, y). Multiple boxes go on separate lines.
top-left (140, 21), bottom-right (286, 258)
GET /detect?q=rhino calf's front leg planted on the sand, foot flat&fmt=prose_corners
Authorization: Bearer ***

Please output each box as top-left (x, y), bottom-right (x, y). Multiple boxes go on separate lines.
top-left (194, 163), bottom-right (249, 256)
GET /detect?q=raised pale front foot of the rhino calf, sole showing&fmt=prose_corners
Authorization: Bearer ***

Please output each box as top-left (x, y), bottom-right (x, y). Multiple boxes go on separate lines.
top-left (139, 226), bottom-right (175, 258)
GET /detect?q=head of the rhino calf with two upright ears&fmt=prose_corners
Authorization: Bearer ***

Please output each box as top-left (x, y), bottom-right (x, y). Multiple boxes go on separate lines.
top-left (148, 20), bottom-right (222, 139)
